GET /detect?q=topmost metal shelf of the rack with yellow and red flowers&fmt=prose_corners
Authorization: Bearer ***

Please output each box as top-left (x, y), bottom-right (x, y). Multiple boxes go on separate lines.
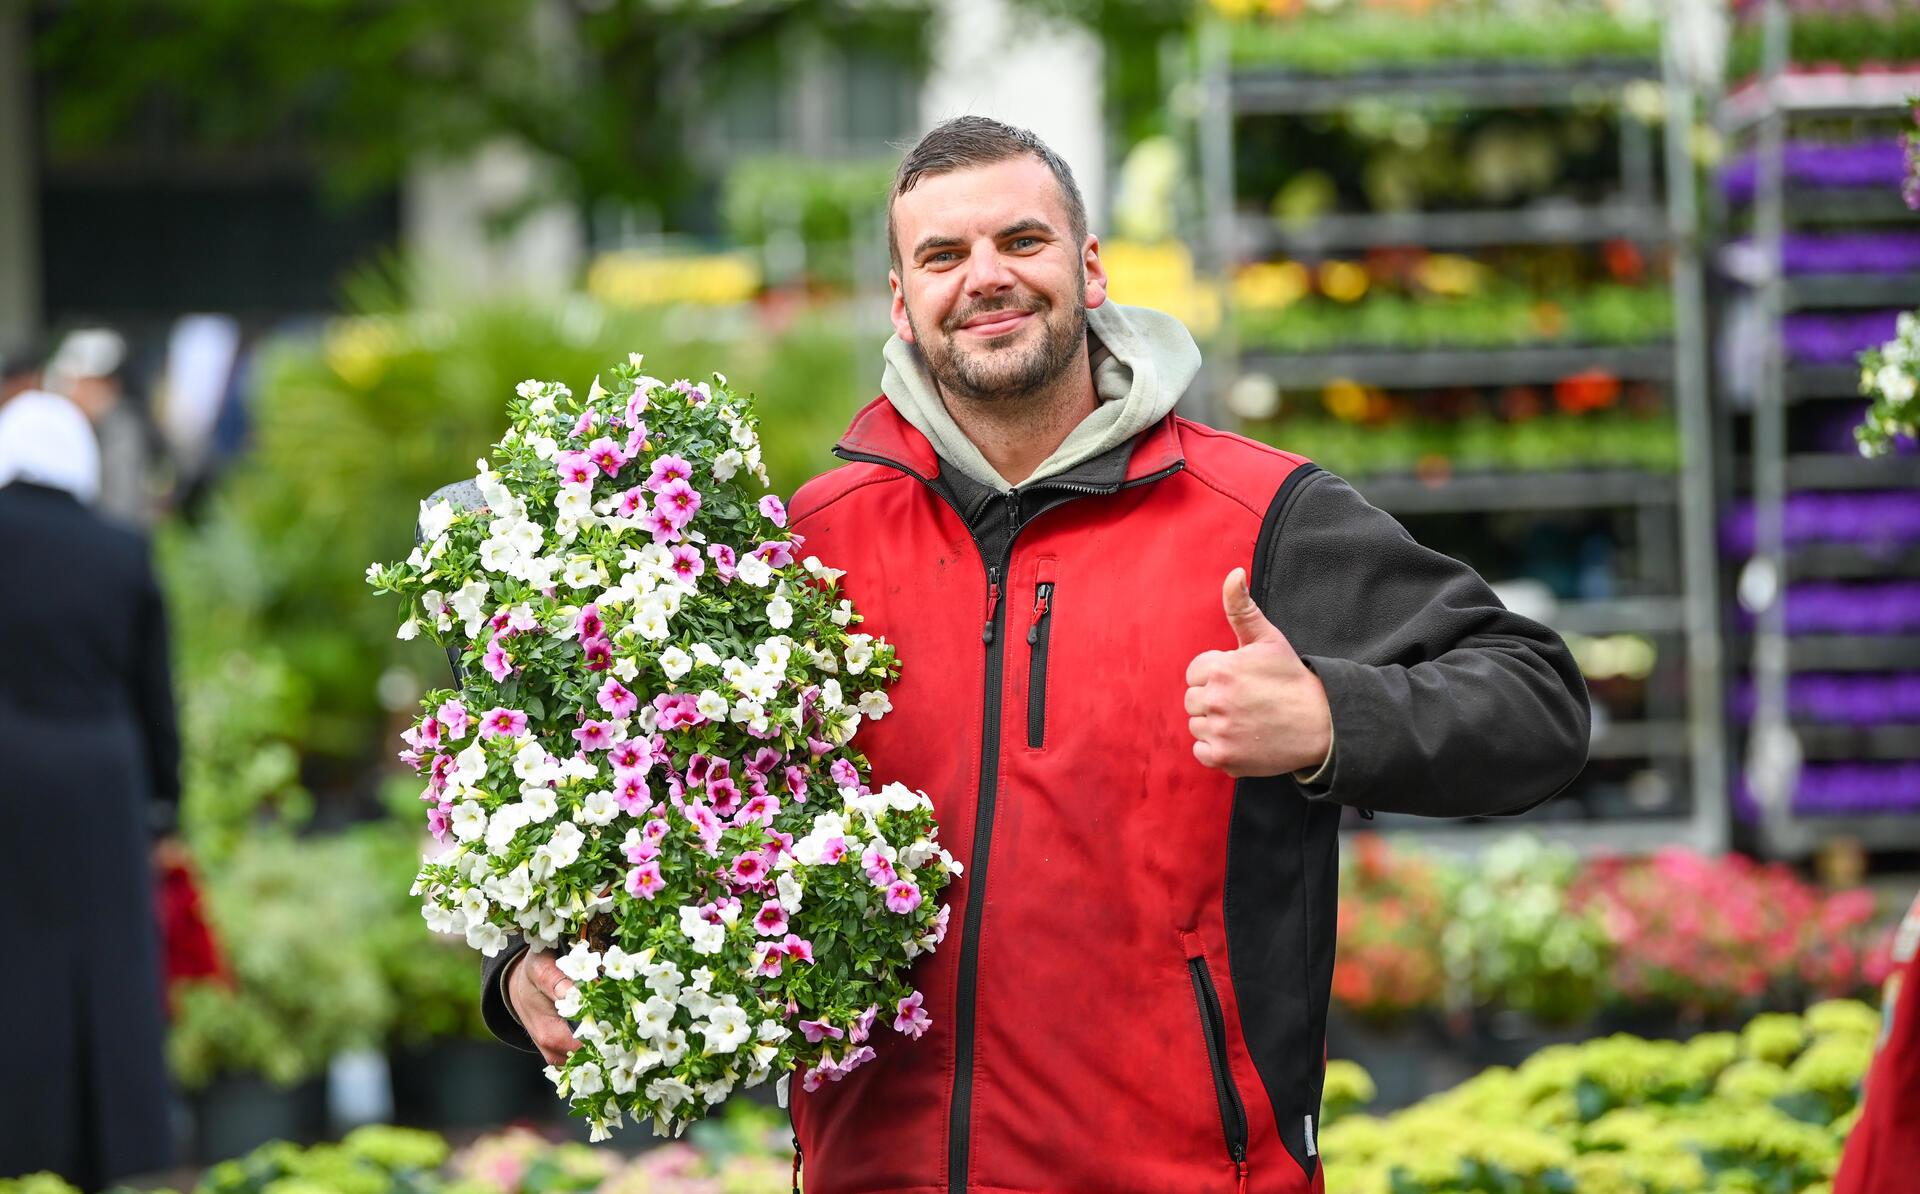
top-left (1229, 58), bottom-right (1661, 115)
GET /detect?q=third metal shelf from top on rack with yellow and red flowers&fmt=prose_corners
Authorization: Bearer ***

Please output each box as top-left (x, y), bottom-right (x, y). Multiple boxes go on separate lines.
top-left (1242, 344), bottom-right (1674, 390)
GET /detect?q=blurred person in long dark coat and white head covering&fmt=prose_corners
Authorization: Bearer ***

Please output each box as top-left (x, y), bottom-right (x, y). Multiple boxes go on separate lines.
top-left (0, 392), bottom-right (179, 1190)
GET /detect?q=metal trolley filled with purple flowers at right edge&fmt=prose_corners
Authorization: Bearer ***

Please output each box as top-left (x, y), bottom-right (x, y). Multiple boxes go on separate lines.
top-left (1715, 0), bottom-right (1920, 858)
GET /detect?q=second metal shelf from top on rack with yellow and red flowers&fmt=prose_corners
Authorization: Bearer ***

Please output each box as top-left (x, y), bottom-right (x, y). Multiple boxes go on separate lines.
top-left (1235, 200), bottom-right (1668, 257)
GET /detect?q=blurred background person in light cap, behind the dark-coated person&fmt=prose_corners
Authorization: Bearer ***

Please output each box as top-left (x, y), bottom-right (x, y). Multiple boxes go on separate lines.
top-left (44, 328), bottom-right (154, 526)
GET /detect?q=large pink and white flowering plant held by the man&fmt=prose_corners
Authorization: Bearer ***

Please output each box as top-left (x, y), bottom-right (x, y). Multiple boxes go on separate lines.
top-left (367, 355), bottom-right (960, 1138)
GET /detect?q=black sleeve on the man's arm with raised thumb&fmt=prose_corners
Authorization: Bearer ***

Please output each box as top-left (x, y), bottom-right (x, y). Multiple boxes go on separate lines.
top-left (1254, 466), bottom-right (1588, 816)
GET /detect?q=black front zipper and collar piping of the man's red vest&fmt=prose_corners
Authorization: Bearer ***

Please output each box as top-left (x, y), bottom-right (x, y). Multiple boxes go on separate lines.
top-left (833, 443), bottom-right (1182, 1190)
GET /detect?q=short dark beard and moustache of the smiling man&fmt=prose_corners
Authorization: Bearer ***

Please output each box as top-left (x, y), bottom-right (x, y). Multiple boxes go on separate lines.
top-left (906, 282), bottom-right (1087, 403)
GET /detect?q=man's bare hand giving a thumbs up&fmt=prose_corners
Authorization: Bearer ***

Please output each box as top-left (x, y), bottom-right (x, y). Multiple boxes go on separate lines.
top-left (1187, 568), bottom-right (1332, 777)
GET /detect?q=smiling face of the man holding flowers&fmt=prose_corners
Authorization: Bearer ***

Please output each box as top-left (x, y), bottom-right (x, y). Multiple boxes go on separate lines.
top-left (889, 157), bottom-right (1106, 401)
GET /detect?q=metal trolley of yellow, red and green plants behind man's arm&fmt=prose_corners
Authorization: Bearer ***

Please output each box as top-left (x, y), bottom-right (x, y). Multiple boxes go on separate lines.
top-left (1192, 7), bottom-right (1730, 852)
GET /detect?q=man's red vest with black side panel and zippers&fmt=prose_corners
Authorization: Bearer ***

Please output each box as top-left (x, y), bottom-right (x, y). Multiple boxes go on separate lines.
top-left (793, 397), bottom-right (1338, 1194)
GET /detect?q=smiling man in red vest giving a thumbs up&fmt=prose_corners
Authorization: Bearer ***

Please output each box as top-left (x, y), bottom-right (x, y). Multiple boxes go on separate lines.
top-left (488, 117), bottom-right (1588, 1194)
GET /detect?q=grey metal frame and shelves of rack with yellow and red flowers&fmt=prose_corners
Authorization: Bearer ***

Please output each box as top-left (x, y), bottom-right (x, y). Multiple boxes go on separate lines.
top-left (1194, 19), bottom-right (1730, 852)
